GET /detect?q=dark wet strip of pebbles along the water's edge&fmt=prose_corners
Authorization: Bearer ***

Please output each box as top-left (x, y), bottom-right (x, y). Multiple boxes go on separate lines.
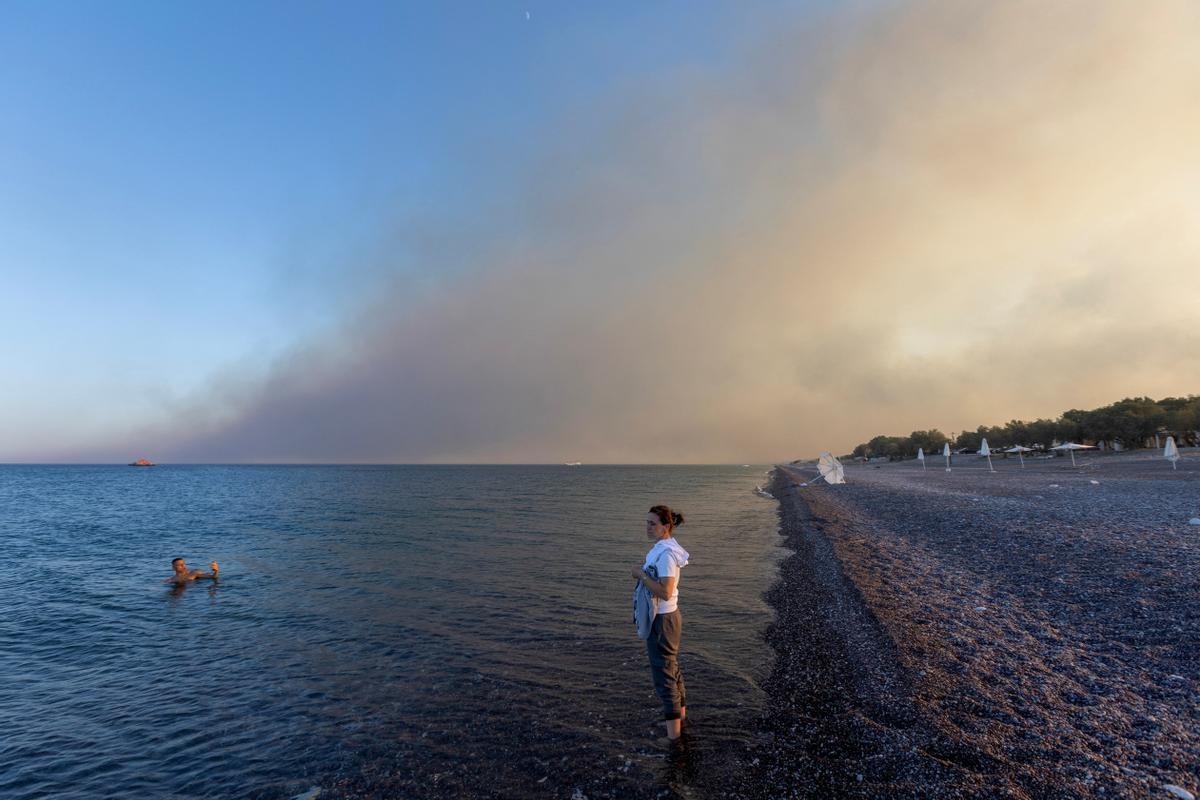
top-left (736, 467), bottom-right (986, 798)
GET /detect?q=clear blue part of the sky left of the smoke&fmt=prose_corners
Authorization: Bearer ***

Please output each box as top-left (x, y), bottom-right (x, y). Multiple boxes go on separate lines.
top-left (0, 1), bottom-right (796, 450)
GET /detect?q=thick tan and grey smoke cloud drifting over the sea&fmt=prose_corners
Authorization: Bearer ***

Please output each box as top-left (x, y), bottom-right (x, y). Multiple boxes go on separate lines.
top-left (72, 0), bottom-right (1200, 462)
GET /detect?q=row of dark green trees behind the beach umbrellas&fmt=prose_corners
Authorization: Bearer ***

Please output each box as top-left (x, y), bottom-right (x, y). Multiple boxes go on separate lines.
top-left (844, 395), bottom-right (1200, 461)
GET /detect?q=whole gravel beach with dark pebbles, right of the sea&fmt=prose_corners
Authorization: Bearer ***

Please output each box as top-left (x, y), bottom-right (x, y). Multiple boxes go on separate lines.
top-left (730, 453), bottom-right (1200, 798)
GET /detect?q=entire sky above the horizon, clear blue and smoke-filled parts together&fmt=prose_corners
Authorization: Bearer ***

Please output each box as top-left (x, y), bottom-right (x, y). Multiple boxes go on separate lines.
top-left (0, 0), bottom-right (1200, 463)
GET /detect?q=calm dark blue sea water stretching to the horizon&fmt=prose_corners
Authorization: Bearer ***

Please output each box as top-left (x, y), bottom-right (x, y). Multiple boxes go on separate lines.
top-left (0, 465), bottom-right (781, 800)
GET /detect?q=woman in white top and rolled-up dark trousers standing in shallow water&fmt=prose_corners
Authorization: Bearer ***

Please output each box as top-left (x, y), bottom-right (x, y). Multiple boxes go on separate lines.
top-left (634, 505), bottom-right (688, 740)
